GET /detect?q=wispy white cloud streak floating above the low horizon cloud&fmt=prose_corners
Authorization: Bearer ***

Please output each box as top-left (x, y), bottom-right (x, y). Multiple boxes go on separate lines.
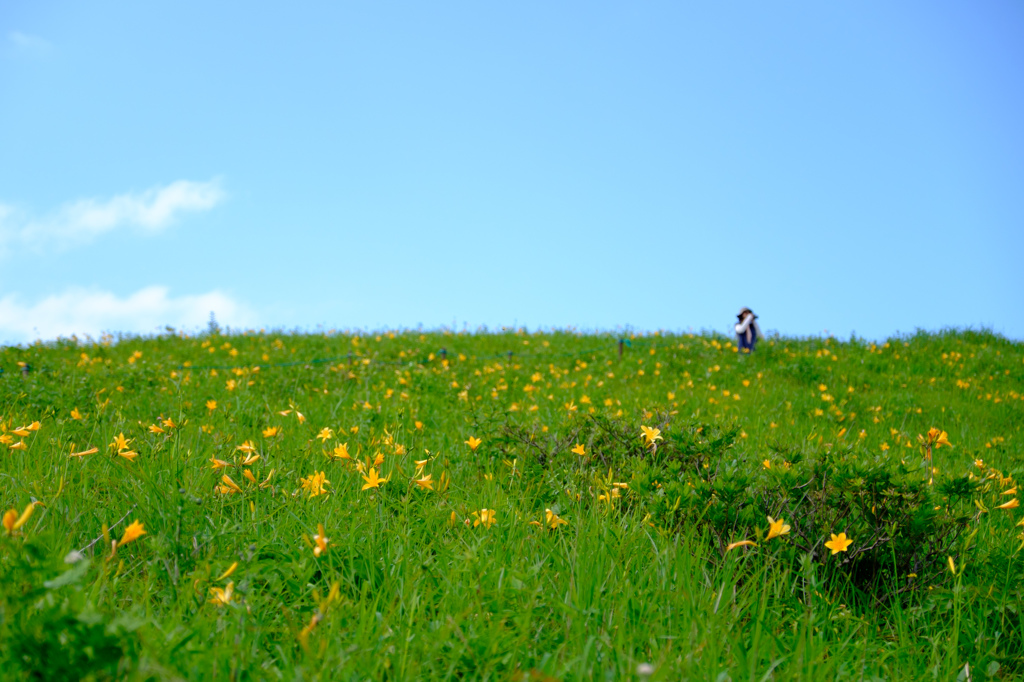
top-left (0, 178), bottom-right (224, 252)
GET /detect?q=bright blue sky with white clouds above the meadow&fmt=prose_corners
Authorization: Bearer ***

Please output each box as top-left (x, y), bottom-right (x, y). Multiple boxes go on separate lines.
top-left (0, 0), bottom-right (1024, 343)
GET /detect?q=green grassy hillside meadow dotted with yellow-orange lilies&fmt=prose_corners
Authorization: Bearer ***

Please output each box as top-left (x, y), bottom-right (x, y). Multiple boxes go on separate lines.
top-left (0, 330), bottom-right (1024, 681)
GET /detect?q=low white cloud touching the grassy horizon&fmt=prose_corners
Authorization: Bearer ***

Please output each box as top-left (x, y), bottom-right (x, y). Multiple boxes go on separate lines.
top-left (0, 287), bottom-right (254, 343)
